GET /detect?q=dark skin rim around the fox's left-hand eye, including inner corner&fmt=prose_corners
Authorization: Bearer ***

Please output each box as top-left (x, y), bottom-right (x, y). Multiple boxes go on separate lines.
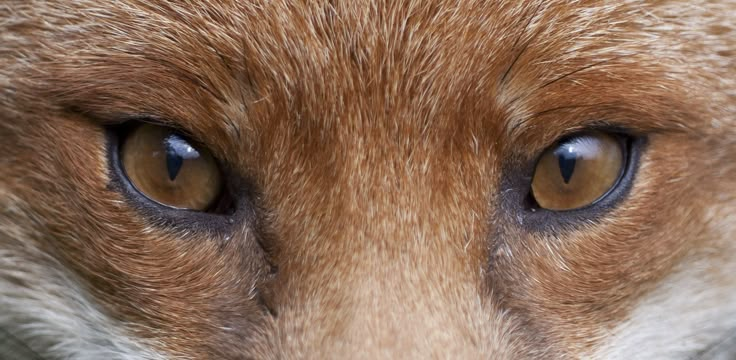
top-left (105, 118), bottom-right (255, 234)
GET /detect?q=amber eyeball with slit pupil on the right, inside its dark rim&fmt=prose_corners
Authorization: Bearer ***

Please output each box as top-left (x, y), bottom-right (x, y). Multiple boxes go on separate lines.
top-left (532, 132), bottom-right (626, 211)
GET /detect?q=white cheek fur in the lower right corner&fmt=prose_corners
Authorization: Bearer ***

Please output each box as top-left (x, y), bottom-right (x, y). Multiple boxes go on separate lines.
top-left (586, 211), bottom-right (736, 360)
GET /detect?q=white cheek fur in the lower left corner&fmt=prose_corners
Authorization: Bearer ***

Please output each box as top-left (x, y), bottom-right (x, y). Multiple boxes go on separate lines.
top-left (0, 194), bottom-right (165, 360)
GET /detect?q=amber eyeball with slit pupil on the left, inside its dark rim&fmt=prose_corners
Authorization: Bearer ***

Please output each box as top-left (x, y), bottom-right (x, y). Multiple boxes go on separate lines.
top-left (120, 124), bottom-right (223, 211)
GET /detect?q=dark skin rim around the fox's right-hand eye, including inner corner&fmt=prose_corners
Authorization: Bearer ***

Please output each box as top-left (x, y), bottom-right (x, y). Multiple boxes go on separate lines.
top-left (498, 125), bottom-right (648, 233)
